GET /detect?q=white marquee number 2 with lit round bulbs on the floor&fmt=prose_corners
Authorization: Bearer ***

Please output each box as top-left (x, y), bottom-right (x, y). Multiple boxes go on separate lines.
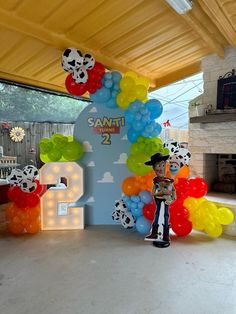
top-left (40, 162), bottom-right (84, 230)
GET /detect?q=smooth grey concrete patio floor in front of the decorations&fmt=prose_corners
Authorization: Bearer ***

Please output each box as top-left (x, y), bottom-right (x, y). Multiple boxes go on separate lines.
top-left (0, 226), bottom-right (236, 314)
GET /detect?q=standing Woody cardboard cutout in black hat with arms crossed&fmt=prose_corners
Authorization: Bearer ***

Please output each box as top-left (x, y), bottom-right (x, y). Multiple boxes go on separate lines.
top-left (145, 153), bottom-right (176, 248)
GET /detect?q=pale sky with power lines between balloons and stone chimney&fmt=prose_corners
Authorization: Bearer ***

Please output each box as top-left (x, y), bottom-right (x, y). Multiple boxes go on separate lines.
top-left (149, 73), bottom-right (203, 129)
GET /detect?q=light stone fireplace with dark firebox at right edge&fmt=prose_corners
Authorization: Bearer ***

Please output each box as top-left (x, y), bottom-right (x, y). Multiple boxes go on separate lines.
top-left (189, 47), bottom-right (236, 235)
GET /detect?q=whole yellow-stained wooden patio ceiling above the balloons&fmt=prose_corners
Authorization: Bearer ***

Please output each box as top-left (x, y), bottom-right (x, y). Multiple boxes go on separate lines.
top-left (0, 0), bottom-right (236, 91)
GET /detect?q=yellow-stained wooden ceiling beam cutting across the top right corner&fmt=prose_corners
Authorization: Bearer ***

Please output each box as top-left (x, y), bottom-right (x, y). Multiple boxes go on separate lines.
top-left (198, 0), bottom-right (236, 48)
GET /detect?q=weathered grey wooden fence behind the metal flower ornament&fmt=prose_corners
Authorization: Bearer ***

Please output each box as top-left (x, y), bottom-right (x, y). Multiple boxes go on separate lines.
top-left (0, 121), bottom-right (74, 167)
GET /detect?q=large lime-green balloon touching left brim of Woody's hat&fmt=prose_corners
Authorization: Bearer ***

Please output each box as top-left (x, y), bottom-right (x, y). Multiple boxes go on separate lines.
top-left (126, 153), bottom-right (152, 176)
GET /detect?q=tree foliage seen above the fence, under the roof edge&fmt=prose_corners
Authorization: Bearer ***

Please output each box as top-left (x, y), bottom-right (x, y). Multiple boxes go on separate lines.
top-left (0, 83), bottom-right (88, 123)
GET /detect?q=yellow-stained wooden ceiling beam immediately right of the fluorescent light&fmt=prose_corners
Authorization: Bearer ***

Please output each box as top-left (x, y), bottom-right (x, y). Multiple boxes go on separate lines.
top-left (164, 1), bottom-right (224, 57)
